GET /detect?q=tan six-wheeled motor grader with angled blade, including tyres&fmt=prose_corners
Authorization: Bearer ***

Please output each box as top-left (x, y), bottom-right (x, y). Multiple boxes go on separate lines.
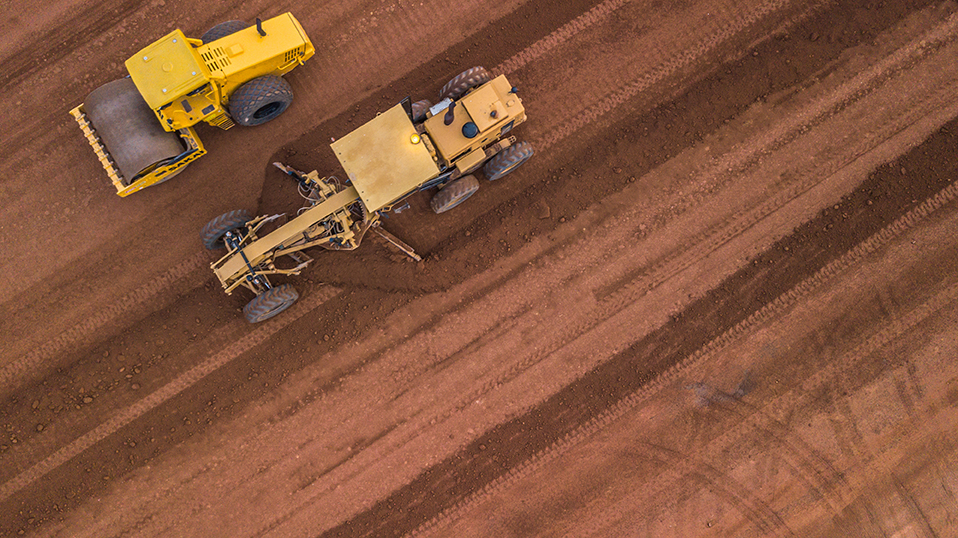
top-left (200, 67), bottom-right (533, 323)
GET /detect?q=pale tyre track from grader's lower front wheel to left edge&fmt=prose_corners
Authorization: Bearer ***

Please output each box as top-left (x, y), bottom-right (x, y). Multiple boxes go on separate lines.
top-left (0, 284), bottom-right (341, 502)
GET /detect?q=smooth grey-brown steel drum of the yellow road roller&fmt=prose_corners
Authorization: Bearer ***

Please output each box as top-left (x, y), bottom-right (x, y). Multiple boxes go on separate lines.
top-left (77, 78), bottom-right (186, 185)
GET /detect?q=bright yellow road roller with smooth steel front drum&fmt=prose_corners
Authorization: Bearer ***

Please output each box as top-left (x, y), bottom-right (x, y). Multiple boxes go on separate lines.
top-left (70, 13), bottom-right (315, 196)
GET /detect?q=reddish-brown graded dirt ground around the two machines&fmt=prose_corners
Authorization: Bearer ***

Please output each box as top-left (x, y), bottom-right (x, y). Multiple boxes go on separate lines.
top-left (0, 0), bottom-right (958, 537)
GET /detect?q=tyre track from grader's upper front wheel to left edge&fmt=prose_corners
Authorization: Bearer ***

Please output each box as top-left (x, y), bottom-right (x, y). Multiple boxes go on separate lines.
top-left (0, 252), bottom-right (209, 390)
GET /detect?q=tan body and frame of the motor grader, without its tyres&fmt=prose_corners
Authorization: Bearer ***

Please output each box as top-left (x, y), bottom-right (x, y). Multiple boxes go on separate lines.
top-left (211, 70), bottom-right (526, 295)
